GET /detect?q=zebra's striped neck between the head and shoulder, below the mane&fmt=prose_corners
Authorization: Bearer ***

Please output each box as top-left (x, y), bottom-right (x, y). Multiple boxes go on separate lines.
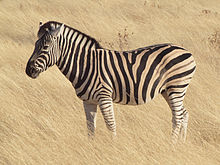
top-left (57, 27), bottom-right (97, 88)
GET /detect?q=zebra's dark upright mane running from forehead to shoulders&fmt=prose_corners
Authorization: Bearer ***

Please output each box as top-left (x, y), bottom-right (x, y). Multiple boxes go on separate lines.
top-left (37, 21), bottom-right (102, 49)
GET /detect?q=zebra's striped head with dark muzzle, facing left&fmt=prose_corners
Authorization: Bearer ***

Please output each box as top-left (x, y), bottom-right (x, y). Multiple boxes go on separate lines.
top-left (26, 23), bottom-right (64, 78)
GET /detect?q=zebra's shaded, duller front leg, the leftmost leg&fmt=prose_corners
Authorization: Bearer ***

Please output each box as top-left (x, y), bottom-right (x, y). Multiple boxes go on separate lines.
top-left (83, 101), bottom-right (97, 137)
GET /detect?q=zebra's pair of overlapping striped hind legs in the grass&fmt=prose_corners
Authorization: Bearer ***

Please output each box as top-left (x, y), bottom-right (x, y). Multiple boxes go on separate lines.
top-left (162, 88), bottom-right (189, 144)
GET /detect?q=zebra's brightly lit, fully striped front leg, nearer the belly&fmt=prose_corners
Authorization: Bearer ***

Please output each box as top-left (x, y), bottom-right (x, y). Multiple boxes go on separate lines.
top-left (99, 97), bottom-right (116, 136)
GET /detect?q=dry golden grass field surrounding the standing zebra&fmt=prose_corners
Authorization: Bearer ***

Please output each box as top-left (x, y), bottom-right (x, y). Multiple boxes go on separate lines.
top-left (0, 0), bottom-right (220, 165)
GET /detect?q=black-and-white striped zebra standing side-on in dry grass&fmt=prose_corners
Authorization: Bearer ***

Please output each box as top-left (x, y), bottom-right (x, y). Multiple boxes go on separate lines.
top-left (26, 21), bottom-right (196, 143)
